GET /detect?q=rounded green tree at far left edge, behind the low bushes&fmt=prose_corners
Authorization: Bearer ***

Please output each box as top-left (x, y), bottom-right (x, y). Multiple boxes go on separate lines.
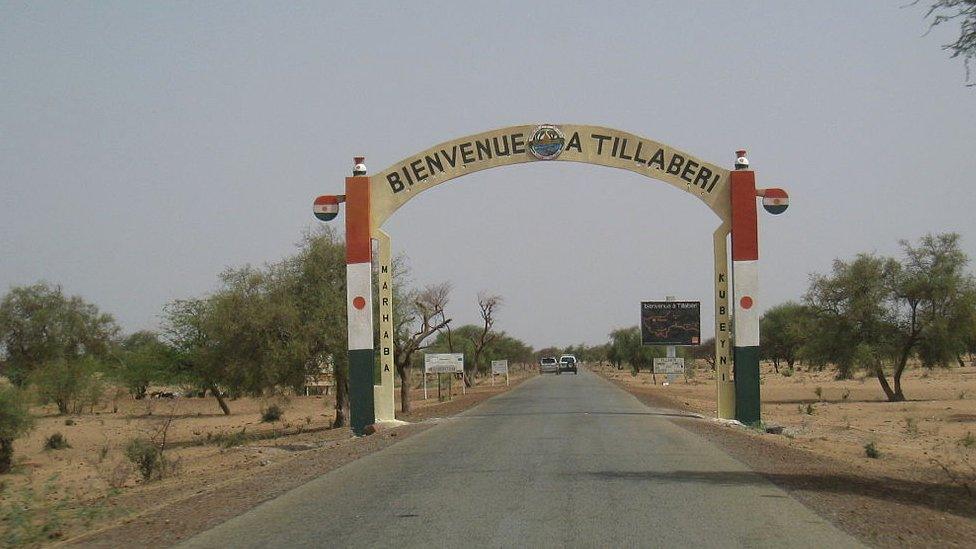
top-left (0, 282), bottom-right (118, 386)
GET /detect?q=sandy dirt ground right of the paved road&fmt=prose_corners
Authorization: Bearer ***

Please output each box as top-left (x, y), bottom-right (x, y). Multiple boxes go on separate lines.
top-left (594, 364), bottom-right (976, 547)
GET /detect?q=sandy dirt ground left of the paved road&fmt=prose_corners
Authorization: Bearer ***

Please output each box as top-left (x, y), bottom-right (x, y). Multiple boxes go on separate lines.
top-left (0, 369), bottom-right (535, 546)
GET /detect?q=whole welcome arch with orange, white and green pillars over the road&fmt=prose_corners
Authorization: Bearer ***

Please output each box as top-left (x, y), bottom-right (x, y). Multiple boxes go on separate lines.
top-left (314, 124), bottom-right (788, 434)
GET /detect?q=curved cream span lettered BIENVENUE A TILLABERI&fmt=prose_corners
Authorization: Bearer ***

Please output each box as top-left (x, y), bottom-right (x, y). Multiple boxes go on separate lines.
top-left (369, 124), bottom-right (730, 231)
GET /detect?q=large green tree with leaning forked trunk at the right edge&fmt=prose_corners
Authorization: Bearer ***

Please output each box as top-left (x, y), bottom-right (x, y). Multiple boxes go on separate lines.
top-left (806, 233), bottom-right (976, 401)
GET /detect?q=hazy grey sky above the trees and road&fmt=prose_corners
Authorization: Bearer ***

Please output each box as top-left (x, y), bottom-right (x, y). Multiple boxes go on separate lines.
top-left (0, 0), bottom-right (976, 347)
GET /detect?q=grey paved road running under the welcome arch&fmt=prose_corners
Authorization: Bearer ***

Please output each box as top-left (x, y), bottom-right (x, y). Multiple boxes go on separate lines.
top-left (186, 372), bottom-right (857, 547)
